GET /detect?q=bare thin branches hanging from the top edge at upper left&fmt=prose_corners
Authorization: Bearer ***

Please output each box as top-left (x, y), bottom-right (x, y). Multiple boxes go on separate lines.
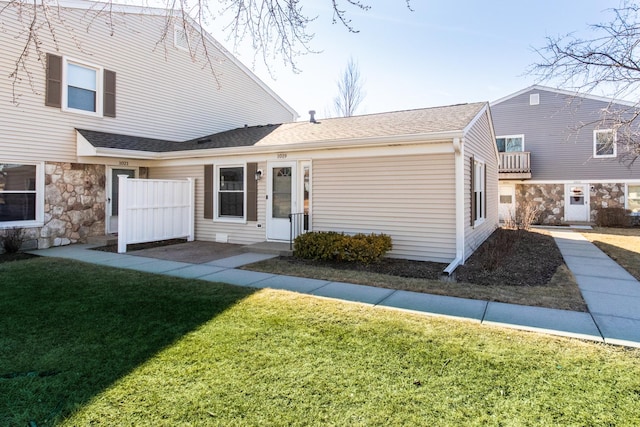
top-left (0, 0), bottom-right (411, 103)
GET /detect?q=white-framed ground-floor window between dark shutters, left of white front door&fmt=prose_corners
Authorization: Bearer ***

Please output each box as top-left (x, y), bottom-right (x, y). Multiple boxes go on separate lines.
top-left (215, 165), bottom-right (246, 221)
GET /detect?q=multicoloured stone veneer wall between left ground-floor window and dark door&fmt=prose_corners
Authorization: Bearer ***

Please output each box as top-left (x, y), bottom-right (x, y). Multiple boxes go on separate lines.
top-left (32, 163), bottom-right (106, 249)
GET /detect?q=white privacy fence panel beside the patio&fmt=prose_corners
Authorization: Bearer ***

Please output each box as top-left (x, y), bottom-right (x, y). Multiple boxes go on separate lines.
top-left (118, 175), bottom-right (195, 253)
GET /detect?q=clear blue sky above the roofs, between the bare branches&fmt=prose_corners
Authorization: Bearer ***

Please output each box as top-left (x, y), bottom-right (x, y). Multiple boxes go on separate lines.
top-left (209, 0), bottom-right (618, 120)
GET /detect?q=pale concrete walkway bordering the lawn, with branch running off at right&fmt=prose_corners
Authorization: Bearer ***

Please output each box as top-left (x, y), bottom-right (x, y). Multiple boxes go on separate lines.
top-left (27, 231), bottom-right (640, 347)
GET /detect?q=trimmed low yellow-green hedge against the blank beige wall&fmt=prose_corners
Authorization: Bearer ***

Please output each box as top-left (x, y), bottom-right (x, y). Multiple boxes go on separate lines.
top-left (294, 231), bottom-right (392, 264)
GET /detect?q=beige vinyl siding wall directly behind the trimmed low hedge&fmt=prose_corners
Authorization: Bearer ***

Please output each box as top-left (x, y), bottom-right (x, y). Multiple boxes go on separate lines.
top-left (311, 154), bottom-right (455, 263)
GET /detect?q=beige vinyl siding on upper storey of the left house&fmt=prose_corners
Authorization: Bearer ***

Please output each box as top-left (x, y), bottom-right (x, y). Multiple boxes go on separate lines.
top-left (0, 3), bottom-right (294, 166)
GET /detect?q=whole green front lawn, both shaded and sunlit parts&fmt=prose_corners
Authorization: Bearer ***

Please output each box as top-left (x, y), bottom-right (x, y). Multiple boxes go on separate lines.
top-left (0, 259), bottom-right (640, 426)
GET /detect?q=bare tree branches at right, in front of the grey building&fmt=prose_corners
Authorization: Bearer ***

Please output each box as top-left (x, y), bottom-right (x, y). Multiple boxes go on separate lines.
top-left (530, 0), bottom-right (640, 166)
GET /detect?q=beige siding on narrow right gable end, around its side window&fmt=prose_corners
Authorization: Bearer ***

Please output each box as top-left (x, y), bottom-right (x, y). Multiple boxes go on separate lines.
top-left (464, 109), bottom-right (498, 258)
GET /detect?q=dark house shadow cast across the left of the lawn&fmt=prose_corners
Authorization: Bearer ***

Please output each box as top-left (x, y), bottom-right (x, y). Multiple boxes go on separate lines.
top-left (0, 258), bottom-right (255, 426)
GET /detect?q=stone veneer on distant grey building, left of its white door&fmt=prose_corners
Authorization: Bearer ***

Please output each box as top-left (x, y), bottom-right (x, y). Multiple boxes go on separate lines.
top-left (516, 184), bottom-right (564, 225)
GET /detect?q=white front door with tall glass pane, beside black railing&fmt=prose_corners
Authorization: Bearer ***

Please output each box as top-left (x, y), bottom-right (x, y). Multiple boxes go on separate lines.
top-left (267, 162), bottom-right (298, 241)
